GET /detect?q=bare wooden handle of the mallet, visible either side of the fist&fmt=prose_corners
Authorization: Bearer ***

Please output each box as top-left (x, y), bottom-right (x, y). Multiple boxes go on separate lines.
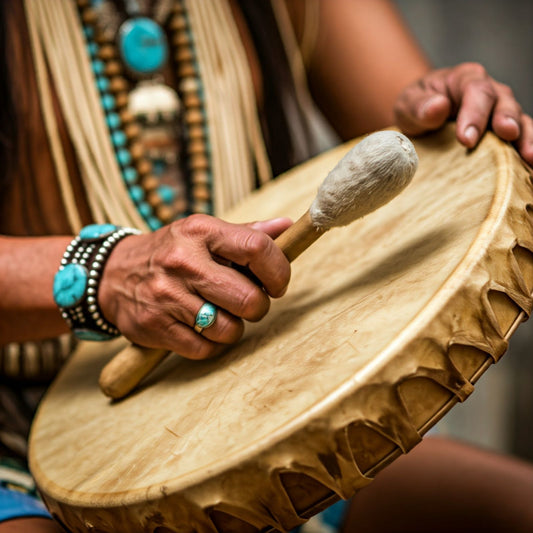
top-left (98, 211), bottom-right (318, 399)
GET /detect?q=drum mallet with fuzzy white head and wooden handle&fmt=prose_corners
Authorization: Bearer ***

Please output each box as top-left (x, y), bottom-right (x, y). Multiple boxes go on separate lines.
top-left (99, 130), bottom-right (418, 399)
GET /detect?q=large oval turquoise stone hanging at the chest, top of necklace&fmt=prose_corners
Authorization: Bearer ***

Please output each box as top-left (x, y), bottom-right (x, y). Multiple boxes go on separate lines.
top-left (118, 17), bottom-right (168, 75)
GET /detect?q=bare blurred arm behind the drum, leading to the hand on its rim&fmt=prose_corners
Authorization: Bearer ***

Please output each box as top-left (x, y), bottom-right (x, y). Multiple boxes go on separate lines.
top-left (302, 0), bottom-right (430, 139)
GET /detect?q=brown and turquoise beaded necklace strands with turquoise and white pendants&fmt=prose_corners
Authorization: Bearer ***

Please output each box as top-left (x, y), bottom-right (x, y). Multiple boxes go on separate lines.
top-left (77, 0), bottom-right (213, 229)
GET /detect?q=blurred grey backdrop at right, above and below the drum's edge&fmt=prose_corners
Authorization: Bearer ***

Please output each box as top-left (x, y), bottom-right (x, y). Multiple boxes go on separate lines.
top-left (394, 0), bottom-right (533, 461)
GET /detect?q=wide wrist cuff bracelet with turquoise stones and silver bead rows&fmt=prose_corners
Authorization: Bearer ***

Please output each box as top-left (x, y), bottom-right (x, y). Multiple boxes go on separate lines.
top-left (54, 224), bottom-right (141, 341)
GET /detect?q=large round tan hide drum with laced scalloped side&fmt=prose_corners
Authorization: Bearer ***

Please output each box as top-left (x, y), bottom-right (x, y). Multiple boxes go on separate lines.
top-left (31, 127), bottom-right (533, 531)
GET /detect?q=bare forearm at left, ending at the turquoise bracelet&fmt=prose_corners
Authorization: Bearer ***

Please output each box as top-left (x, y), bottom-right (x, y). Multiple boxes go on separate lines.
top-left (0, 236), bottom-right (72, 345)
